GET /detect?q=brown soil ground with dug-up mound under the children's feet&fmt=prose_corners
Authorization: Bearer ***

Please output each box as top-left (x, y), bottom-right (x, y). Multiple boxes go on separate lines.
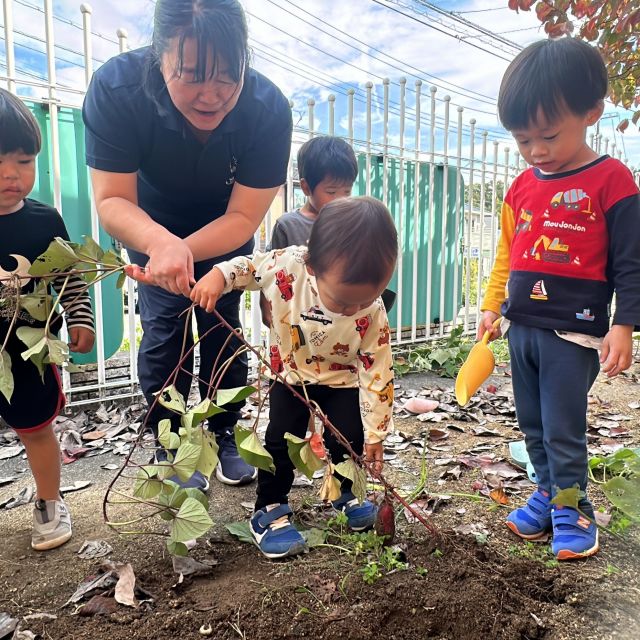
top-left (0, 364), bottom-right (640, 640)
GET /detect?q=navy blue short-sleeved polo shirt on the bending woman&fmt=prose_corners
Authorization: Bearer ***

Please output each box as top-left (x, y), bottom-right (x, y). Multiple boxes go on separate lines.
top-left (82, 47), bottom-right (292, 255)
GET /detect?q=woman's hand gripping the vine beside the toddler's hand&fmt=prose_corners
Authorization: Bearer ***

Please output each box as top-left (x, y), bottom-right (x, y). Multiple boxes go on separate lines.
top-left (125, 234), bottom-right (195, 298)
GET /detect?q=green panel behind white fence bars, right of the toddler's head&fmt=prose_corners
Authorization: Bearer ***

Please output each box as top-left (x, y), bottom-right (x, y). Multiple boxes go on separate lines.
top-left (354, 154), bottom-right (464, 329)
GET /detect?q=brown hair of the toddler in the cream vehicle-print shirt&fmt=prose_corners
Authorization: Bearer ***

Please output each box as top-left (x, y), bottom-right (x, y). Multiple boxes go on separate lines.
top-left (307, 196), bottom-right (398, 284)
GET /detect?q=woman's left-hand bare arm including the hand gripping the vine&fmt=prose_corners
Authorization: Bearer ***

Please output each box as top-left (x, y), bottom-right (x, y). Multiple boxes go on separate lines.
top-left (91, 169), bottom-right (194, 296)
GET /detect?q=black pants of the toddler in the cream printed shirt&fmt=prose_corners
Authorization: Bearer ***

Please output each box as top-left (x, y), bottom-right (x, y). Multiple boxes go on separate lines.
top-left (256, 382), bottom-right (364, 510)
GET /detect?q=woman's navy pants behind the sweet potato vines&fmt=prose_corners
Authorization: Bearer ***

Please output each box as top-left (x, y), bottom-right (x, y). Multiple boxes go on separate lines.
top-left (129, 250), bottom-right (248, 434)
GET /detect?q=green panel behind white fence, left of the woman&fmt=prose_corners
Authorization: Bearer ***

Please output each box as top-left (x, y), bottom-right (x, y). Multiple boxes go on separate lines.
top-left (27, 102), bottom-right (124, 364)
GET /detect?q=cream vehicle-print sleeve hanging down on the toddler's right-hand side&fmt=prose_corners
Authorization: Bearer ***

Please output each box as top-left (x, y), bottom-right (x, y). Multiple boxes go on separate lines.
top-left (358, 305), bottom-right (394, 444)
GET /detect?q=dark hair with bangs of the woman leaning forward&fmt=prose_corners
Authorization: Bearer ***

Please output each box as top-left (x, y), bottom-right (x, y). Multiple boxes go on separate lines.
top-left (145, 0), bottom-right (249, 92)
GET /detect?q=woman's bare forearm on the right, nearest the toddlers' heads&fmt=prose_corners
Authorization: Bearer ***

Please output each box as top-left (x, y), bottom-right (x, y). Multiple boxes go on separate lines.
top-left (185, 182), bottom-right (280, 262)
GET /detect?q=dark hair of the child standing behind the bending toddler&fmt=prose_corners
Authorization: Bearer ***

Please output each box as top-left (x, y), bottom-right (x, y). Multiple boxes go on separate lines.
top-left (298, 136), bottom-right (358, 191)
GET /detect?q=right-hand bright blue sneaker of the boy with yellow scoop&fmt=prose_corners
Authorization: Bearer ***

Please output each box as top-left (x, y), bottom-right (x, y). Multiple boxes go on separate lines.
top-left (551, 506), bottom-right (600, 560)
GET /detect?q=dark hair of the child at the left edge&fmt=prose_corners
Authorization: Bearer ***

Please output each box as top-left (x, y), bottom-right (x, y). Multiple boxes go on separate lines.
top-left (0, 89), bottom-right (42, 156)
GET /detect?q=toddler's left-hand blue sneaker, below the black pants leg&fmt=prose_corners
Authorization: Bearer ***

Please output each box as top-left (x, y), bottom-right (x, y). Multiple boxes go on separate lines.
top-left (250, 504), bottom-right (308, 559)
